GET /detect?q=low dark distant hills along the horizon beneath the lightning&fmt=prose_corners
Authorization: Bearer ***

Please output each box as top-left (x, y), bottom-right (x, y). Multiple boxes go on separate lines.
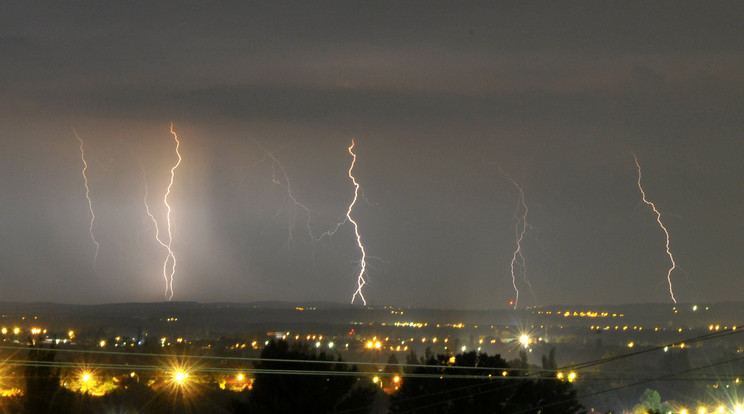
top-left (0, 301), bottom-right (744, 342)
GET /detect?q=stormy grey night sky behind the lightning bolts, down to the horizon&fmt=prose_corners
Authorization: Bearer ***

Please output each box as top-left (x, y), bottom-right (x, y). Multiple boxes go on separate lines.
top-left (0, 0), bottom-right (744, 308)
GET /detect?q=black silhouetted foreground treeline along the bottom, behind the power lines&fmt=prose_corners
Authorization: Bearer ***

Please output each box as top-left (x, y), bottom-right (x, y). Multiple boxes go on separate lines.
top-left (5, 341), bottom-right (584, 414)
